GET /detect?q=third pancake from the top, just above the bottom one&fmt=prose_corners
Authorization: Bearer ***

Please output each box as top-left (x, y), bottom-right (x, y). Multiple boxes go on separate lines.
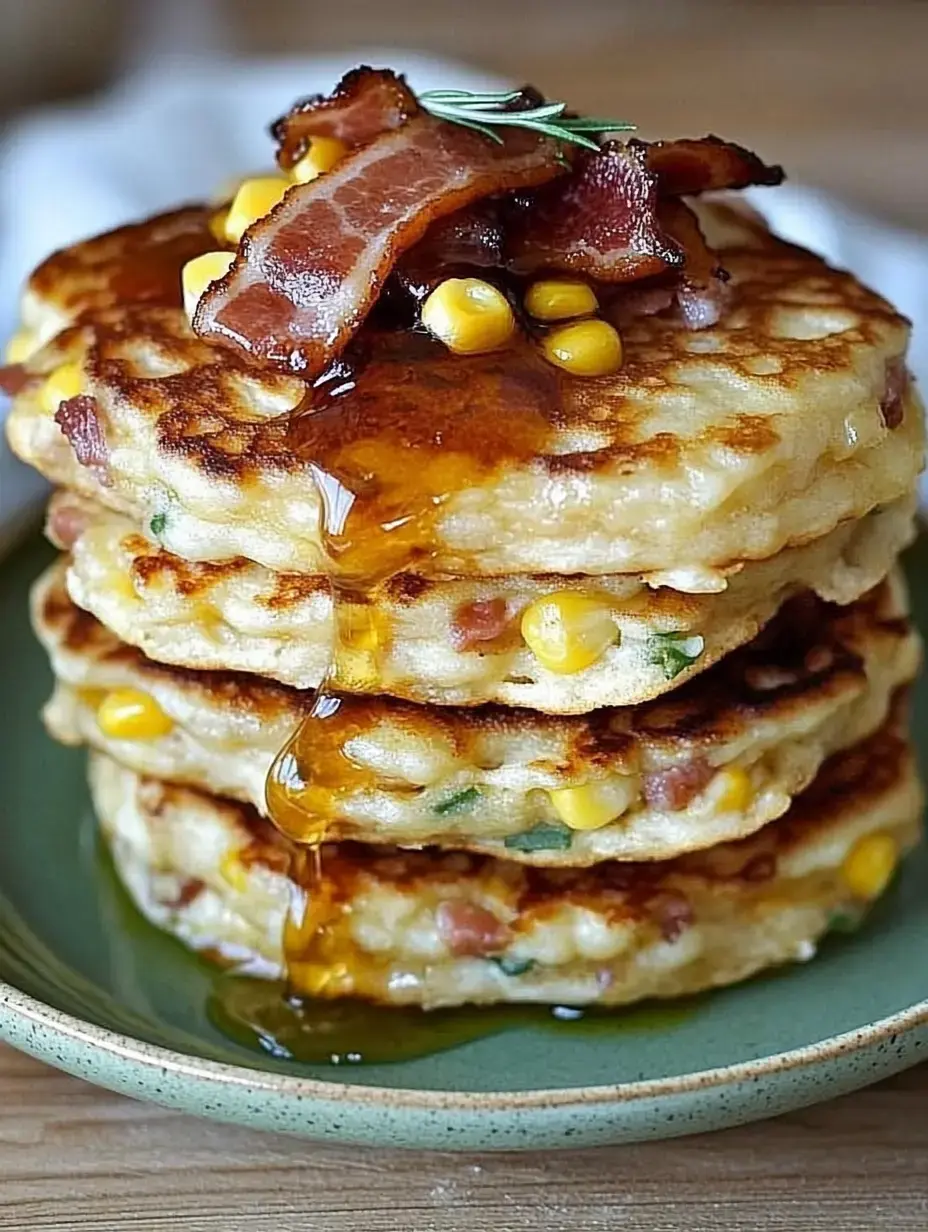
top-left (35, 569), bottom-right (919, 866)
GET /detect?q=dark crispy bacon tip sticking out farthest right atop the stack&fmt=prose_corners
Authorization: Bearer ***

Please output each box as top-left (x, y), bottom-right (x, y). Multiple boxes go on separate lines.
top-left (645, 137), bottom-right (784, 197)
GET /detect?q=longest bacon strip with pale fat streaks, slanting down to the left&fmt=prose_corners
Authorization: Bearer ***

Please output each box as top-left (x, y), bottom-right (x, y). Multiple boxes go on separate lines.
top-left (193, 112), bottom-right (563, 378)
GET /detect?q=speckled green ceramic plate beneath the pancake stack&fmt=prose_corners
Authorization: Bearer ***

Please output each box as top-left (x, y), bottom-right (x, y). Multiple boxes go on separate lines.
top-left (0, 540), bottom-right (928, 1149)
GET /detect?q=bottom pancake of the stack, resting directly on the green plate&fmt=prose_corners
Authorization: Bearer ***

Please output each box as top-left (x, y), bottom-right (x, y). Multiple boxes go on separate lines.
top-left (90, 718), bottom-right (922, 1008)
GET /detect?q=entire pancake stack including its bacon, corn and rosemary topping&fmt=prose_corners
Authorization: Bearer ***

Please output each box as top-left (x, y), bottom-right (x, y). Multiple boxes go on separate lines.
top-left (0, 69), bottom-right (924, 1009)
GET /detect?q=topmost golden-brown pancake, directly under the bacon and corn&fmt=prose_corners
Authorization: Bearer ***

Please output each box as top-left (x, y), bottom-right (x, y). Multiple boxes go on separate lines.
top-left (7, 203), bottom-right (923, 591)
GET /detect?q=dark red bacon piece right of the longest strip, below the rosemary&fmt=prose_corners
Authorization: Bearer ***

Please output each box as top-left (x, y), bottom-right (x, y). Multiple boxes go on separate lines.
top-left (507, 142), bottom-right (683, 282)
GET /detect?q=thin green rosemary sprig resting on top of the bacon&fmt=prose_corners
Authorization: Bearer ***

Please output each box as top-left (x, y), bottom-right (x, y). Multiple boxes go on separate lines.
top-left (419, 90), bottom-right (635, 150)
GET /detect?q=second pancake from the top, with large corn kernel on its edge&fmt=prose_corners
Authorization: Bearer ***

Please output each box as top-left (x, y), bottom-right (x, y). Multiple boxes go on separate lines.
top-left (48, 493), bottom-right (914, 713)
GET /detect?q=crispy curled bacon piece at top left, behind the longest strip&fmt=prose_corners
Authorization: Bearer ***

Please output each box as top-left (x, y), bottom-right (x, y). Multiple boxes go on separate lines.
top-left (271, 64), bottom-right (419, 170)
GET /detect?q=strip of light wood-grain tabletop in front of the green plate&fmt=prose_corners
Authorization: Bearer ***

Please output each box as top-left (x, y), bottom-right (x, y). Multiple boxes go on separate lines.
top-left (0, 1047), bottom-right (928, 1232)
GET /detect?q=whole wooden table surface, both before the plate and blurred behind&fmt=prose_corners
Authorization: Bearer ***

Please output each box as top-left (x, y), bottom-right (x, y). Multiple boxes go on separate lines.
top-left (0, 0), bottom-right (928, 1232)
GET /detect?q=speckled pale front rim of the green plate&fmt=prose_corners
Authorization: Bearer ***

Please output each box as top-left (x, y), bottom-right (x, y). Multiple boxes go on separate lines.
top-left (0, 981), bottom-right (928, 1149)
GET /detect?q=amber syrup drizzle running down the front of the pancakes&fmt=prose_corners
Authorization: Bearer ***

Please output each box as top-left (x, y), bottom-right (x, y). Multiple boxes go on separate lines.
top-left (266, 329), bottom-right (568, 995)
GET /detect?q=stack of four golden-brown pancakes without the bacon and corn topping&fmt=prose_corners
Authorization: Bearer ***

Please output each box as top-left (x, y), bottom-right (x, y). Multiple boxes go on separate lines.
top-left (7, 197), bottom-right (923, 1007)
